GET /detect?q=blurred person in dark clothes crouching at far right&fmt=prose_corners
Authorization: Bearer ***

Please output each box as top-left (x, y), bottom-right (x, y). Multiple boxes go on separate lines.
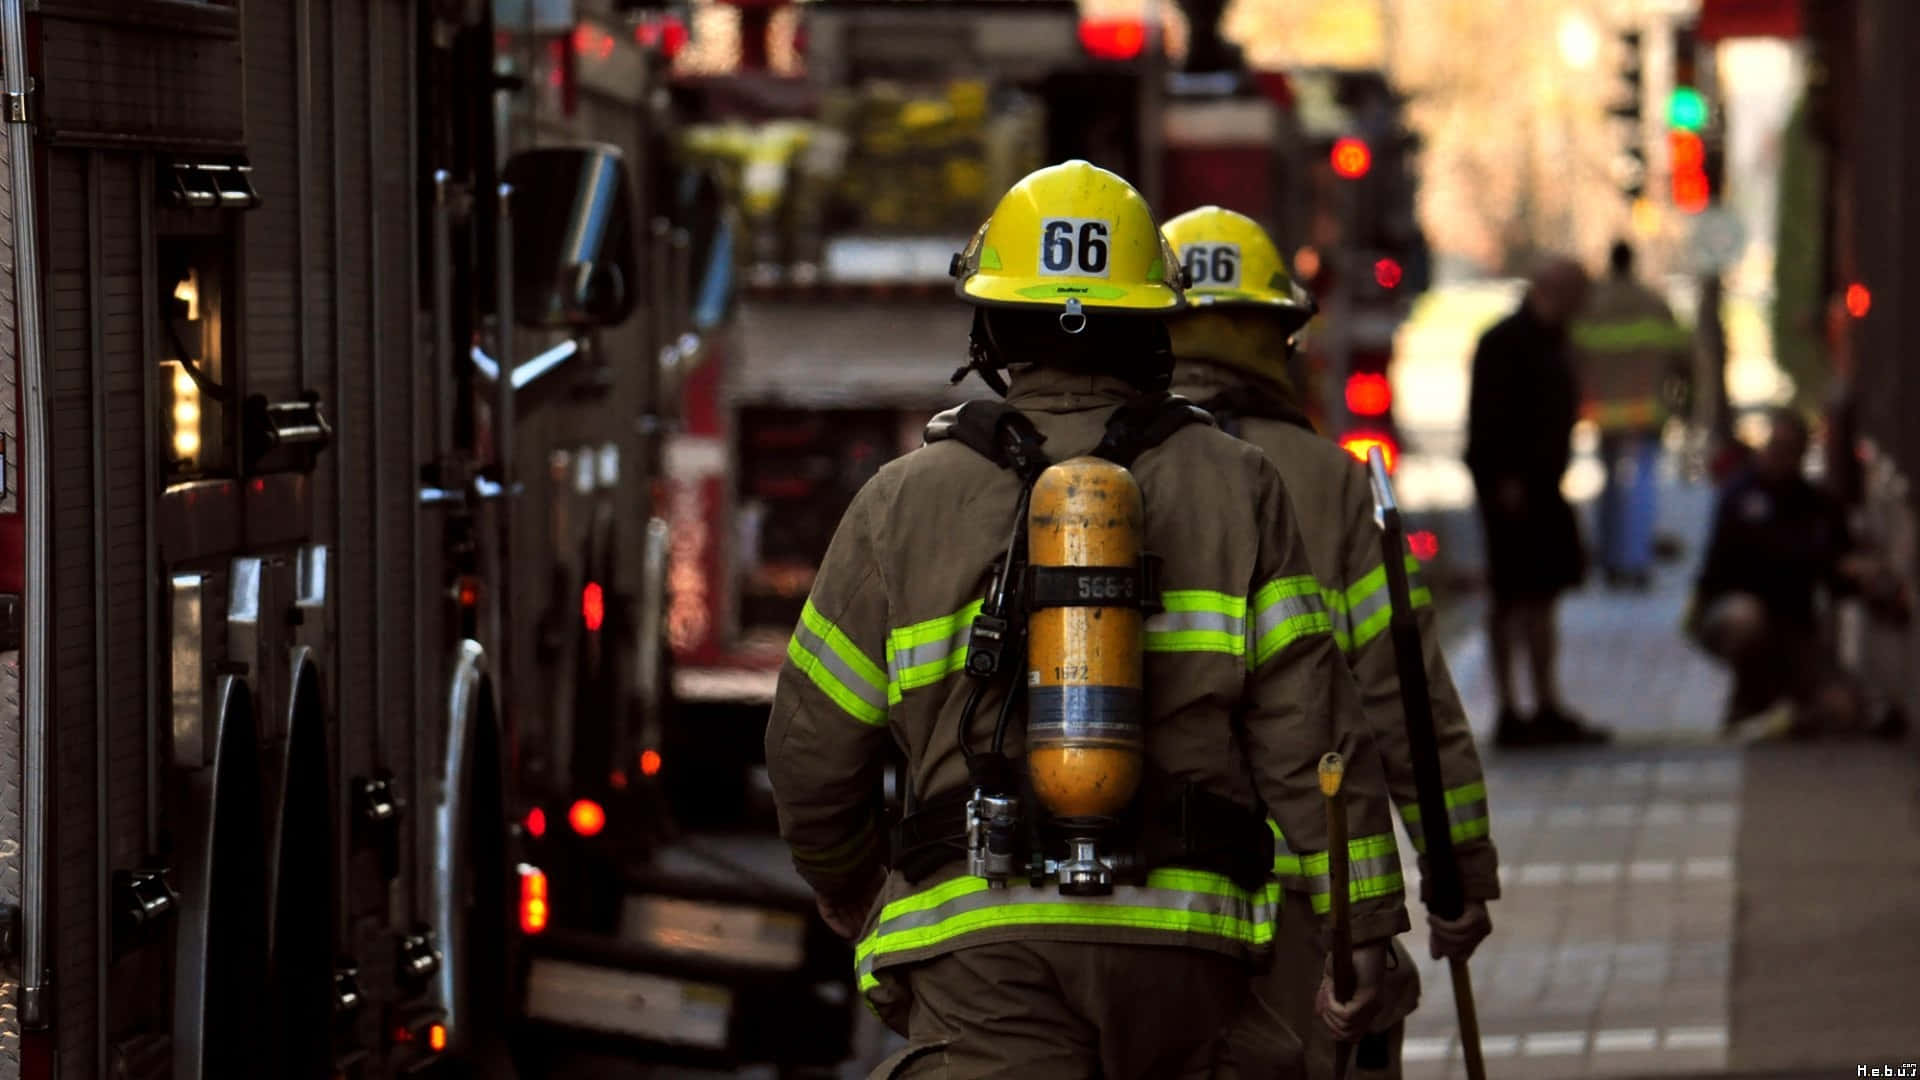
top-left (1686, 409), bottom-right (1907, 736)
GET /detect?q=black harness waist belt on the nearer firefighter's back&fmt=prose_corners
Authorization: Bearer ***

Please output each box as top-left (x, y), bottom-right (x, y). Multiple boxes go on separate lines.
top-left (889, 772), bottom-right (1273, 892)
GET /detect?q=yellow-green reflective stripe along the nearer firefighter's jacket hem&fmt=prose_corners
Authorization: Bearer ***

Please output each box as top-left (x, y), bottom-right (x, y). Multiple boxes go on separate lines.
top-left (854, 869), bottom-right (1275, 982)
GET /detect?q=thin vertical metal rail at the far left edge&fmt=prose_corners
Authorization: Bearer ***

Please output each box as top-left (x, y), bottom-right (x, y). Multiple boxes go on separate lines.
top-left (0, 0), bottom-right (52, 1028)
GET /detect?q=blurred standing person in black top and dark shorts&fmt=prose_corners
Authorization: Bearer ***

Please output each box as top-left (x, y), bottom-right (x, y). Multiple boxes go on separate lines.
top-left (1467, 258), bottom-right (1611, 748)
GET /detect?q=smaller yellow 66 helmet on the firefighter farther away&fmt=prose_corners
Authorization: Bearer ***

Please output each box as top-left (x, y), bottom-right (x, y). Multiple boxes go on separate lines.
top-left (1165, 206), bottom-right (1313, 326)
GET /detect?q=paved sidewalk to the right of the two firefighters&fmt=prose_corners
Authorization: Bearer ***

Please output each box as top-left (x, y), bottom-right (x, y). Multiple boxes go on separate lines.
top-left (1397, 472), bottom-right (1920, 1080)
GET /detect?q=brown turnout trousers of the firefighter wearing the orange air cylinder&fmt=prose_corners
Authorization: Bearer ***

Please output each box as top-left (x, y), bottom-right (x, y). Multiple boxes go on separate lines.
top-left (870, 942), bottom-right (1271, 1080)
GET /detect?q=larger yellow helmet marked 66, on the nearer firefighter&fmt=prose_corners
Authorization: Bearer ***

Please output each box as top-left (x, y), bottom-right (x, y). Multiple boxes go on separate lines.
top-left (952, 161), bottom-right (1187, 313)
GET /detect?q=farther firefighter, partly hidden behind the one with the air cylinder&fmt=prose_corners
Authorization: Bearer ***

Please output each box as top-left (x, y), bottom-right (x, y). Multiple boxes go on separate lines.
top-left (1164, 206), bottom-right (1500, 1080)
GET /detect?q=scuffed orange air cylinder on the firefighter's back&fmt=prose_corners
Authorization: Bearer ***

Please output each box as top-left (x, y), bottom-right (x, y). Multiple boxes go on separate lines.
top-left (1027, 457), bottom-right (1146, 824)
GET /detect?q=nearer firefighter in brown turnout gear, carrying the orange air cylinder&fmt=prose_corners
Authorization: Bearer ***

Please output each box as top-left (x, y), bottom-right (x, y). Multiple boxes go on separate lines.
top-left (766, 161), bottom-right (1407, 1080)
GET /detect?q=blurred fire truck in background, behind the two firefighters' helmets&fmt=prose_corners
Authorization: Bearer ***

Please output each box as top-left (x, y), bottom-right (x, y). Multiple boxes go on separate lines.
top-left (666, 0), bottom-right (1425, 768)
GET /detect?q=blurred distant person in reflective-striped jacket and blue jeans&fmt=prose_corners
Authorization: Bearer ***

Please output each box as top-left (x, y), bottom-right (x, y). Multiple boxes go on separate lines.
top-left (1572, 240), bottom-right (1693, 588)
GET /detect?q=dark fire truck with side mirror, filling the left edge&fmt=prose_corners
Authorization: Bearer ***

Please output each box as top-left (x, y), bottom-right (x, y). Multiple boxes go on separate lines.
top-left (0, 0), bottom-right (741, 1080)
